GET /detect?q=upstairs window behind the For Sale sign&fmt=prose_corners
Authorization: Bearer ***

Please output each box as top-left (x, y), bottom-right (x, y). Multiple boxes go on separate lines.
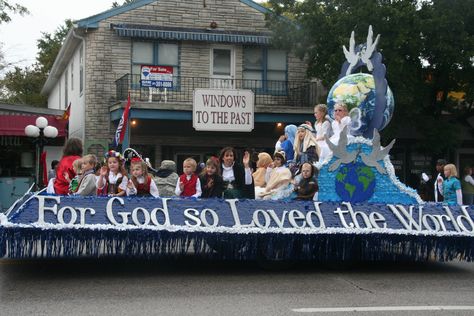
top-left (132, 42), bottom-right (179, 87)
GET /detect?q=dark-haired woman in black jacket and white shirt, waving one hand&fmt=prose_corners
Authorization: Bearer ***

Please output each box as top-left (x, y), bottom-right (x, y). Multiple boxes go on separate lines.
top-left (219, 147), bottom-right (255, 199)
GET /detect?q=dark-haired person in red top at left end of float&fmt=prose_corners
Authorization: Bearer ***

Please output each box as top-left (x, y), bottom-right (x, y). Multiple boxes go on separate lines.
top-left (54, 138), bottom-right (82, 195)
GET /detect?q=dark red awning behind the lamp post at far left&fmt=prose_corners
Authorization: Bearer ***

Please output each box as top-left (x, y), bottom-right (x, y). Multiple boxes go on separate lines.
top-left (0, 114), bottom-right (67, 137)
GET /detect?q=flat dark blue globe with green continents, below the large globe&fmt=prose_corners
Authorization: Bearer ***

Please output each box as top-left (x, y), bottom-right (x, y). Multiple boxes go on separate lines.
top-left (336, 162), bottom-right (375, 203)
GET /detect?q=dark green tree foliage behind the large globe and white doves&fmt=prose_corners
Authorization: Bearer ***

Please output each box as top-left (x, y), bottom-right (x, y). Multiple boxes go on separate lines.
top-left (269, 0), bottom-right (474, 153)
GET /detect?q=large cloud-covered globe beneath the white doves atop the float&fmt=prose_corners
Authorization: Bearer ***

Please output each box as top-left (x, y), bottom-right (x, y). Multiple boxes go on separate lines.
top-left (327, 73), bottom-right (395, 136)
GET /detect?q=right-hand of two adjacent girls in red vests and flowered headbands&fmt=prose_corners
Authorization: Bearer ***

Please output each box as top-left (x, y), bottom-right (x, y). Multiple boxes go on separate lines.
top-left (126, 157), bottom-right (160, 197)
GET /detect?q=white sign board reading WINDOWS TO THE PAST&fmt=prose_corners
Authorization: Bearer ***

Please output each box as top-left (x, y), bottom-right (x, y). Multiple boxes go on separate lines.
top-left (193, 89), bottom-right (254, 132)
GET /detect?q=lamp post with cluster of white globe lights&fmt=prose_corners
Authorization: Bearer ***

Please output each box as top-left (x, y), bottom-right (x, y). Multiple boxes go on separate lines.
top-left (25, 116), bottom-right (58, 189)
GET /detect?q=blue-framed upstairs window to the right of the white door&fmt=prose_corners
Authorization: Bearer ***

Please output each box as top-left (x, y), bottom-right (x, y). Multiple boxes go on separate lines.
top-left (243, 47), bottom-right (288, 94)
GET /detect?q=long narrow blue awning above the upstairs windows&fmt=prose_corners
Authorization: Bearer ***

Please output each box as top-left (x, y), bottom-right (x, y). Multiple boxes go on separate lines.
top-left (111, 24), bottom-right (270, 45)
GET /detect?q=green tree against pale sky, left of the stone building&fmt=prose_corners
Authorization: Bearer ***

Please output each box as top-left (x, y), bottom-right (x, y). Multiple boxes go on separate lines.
top-left (0, 20), bottom-right (72, 106)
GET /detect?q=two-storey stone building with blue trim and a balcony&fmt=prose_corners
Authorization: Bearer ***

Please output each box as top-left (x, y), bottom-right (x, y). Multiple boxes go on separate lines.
top-left (43, 0), bottom-right (320, 173)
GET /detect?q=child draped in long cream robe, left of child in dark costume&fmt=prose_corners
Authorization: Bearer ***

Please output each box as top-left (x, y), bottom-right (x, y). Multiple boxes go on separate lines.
top-left (257, 151), bottom-right (293, 200)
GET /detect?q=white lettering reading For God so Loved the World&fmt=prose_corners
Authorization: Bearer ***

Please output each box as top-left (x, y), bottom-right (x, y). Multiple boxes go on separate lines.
top-left (35, 195), bottom-right (474, 235)
